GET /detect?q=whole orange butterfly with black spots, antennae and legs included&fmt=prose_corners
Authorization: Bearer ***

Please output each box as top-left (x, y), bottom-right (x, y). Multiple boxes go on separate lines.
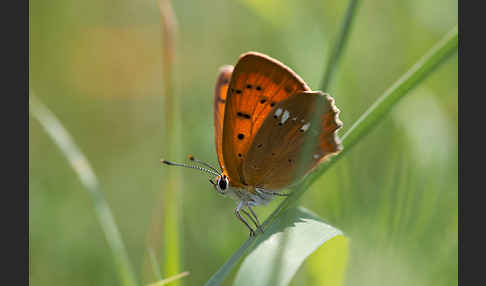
top-left (161, 52), bottom-right (343, 236)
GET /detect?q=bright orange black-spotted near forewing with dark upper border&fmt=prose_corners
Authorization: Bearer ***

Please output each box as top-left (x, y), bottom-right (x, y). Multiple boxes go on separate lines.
top-left (223, 52), bottom-right (310, 187)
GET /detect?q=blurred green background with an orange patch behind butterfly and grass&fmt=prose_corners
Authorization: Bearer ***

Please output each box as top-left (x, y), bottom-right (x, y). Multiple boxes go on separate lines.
top-left (29, 0), bottom-right (458, 286)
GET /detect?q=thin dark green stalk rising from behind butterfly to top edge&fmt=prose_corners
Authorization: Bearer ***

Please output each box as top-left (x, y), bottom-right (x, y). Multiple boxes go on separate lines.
top-left (321, 0), bottom-right (360, 92)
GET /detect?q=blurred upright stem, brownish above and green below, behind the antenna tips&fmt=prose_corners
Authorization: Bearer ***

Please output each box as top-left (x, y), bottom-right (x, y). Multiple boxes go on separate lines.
top-left (143, 0), bottom-right (183, 285)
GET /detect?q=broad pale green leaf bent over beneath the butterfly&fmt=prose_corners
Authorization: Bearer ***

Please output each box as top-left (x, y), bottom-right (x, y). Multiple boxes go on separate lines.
top-left (234, 208), bottom-right (347, 286)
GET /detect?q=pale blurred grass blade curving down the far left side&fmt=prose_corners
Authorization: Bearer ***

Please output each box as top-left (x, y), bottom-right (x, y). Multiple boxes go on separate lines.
top-left (29, 93), bottom-right (137, 286)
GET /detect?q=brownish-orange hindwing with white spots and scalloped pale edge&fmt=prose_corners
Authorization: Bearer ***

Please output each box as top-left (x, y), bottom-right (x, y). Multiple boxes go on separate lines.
top-left (243, 91), bottom-right (342, 190)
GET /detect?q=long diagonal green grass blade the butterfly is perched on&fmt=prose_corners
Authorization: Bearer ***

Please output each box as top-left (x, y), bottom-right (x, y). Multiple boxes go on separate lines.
top-left (205, 27), bottom-right (458, 285)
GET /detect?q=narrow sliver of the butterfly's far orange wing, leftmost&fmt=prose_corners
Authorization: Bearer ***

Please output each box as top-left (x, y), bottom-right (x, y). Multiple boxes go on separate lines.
top-left (214, 66), bottom-right (233, 170)
